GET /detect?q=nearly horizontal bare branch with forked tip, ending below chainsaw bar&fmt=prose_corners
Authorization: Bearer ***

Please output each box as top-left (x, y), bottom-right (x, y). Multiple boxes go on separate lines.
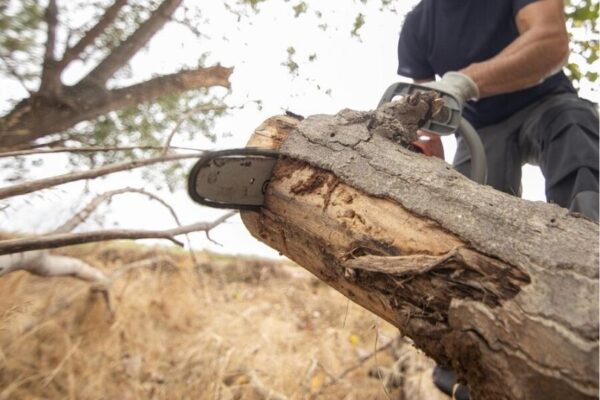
top-left (0, 212), bottom-right (236, 255)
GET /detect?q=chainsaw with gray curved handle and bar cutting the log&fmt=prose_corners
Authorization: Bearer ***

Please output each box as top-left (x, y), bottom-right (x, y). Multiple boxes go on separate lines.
top-left (188, 82), bottom-right (487, 211)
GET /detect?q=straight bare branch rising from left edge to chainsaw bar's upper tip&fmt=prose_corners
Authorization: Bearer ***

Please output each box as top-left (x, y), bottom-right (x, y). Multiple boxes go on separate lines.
top-left (0, 154), bottom-right (198, 200)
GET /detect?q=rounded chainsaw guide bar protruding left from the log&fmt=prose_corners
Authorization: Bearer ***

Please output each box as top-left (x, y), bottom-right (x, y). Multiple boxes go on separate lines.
top-left (188, 147), bottom-right (279, 211)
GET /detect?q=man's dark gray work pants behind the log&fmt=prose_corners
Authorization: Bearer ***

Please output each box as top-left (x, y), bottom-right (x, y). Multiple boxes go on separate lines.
top-left (454, 93), bottom-right (598, 221)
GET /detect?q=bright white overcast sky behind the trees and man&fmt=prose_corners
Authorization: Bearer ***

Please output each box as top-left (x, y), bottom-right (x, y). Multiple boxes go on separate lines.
top-left (0, 0), bottom-right (590, 256)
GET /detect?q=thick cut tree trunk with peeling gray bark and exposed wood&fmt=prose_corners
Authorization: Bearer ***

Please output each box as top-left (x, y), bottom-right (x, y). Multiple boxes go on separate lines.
top-left (242, 101), bottom-right (598, 399)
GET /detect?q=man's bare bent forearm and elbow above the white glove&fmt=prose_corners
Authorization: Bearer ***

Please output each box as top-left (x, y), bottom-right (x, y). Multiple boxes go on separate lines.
top-left (460, 0), bottom-right (569, 97)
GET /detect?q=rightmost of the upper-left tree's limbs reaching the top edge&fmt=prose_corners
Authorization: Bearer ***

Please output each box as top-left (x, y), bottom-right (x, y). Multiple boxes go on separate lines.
top-left (80, 0), bottom-right (182, 87)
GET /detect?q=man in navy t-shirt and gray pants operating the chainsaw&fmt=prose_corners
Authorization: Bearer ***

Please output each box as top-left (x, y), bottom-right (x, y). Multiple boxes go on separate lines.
top-left (398, 0), bottom-right (598, 221)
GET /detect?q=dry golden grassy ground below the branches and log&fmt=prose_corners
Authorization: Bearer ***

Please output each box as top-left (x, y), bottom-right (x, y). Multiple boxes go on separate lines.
top-left (0, 243), bottom-right (447, 400)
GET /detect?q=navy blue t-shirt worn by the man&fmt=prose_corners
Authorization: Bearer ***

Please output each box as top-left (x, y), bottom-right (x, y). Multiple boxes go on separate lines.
top-left (398, 0), bottom-right (575, 128)
